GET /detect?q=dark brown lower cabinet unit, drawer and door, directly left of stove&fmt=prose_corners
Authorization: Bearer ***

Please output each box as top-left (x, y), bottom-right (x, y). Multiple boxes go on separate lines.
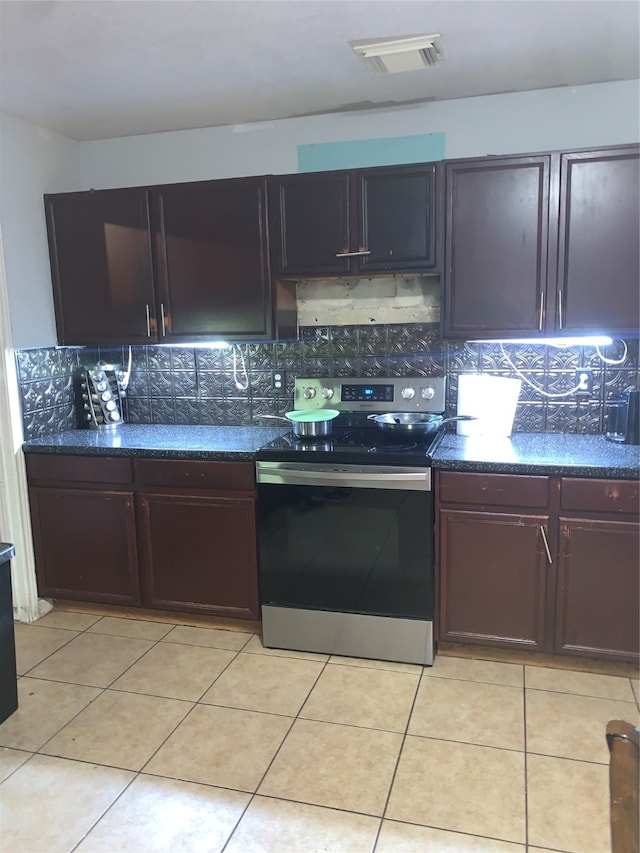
top-left (134, 459), bottom-right (258, 619)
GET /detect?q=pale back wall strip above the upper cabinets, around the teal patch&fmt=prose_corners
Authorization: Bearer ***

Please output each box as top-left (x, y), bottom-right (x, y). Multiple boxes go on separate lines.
top-left (69, 81), bottom-right (640, 189)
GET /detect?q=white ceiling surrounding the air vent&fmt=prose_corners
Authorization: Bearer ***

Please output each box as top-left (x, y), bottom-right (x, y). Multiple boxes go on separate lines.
top-left (0, 0), bottom-right (640, 140)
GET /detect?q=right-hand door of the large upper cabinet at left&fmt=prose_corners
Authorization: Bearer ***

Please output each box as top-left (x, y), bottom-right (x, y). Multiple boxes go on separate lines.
top-left (149, 178), bottom-right (271, 343)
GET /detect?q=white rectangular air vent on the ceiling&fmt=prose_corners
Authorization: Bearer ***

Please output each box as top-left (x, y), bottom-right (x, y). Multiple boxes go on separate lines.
top-left (349, 33), bottom-right (447, 74)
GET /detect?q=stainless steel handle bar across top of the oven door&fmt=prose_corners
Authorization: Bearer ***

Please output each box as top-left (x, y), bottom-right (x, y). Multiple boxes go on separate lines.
top-left (257, 468), bottom-right (431, 491)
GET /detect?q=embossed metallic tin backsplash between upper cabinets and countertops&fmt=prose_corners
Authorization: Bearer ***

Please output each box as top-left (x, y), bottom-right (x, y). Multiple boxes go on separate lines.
top-left (17, 323), bottom-right (640, 439)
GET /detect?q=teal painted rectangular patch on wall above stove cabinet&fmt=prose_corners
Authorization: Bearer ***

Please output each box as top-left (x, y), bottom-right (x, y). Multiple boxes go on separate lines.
top-left (298, 133), bottom-right (445, 172)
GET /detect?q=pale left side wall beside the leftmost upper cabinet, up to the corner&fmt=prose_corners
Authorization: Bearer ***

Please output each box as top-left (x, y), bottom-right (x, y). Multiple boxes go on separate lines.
top-left (0, 113), bottom-right (79, 347)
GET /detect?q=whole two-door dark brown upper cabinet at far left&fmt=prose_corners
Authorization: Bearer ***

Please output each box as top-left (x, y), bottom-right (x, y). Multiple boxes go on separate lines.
top-left (45, 178), bottom-right (282, 345)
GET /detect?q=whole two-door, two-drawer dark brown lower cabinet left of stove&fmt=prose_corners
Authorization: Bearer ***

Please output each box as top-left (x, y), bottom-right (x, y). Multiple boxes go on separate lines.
top-left (26, 454), bottom-right (259, 619)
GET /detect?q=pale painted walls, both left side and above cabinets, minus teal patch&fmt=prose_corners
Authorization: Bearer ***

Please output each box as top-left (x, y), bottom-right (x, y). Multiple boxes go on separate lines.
top-left (0, 76), bottom-right (640, 348)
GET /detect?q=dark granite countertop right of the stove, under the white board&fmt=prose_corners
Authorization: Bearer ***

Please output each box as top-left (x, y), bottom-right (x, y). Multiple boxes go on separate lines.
top-left (433, 433), bottom-right (640, 480)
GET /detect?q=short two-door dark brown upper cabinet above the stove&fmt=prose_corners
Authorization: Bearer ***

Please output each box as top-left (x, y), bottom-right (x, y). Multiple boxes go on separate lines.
top-left (270, 163), bottom-right (438, 277)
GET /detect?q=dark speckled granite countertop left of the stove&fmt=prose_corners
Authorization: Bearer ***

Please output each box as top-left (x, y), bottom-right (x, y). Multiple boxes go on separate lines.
top-left (22, 424), bottom-right (288, 461)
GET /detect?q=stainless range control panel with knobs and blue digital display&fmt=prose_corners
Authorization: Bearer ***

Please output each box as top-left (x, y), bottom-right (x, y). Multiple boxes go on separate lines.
top-left (294, 376), bottom-right (445, 413)
